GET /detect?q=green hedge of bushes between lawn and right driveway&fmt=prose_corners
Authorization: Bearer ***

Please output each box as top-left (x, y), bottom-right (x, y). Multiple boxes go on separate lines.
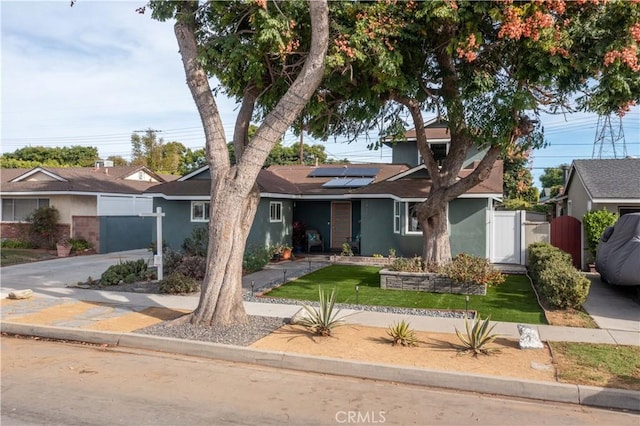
top-left (529, 243), bottom-right (590, 309)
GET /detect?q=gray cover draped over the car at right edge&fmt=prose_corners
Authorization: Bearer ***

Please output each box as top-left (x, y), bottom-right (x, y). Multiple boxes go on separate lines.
top-left (596, 213), bottom-right (640, 285)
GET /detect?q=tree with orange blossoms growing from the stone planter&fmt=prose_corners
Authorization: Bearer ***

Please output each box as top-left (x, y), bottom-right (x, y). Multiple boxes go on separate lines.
top-left (305, 0), bottom-right (640, 264)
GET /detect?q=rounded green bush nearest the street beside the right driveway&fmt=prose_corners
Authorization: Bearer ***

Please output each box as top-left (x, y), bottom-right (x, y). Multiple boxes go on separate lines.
top-left (538, 261), bottom-right (591, 309)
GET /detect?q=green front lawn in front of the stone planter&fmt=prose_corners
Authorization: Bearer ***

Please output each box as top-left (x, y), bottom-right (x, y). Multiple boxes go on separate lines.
top-left (266, 265), bottom-right (547, 324)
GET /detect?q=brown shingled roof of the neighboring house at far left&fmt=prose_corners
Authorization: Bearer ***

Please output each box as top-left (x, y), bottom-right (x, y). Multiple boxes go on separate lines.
top-left (0, 166), bottom-right (164, 195)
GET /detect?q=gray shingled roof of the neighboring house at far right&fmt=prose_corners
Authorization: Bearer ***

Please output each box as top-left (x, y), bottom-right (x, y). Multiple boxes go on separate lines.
top-left (565, 158), bottom-right (640, 200)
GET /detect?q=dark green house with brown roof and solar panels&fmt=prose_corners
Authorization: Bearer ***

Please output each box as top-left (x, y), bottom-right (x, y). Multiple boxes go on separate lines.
top-left (146, 118), bottom-right (502, 258)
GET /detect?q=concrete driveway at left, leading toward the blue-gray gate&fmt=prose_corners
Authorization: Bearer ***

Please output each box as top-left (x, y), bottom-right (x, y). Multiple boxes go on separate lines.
top-left (0, 249), bottom-right (153, 298)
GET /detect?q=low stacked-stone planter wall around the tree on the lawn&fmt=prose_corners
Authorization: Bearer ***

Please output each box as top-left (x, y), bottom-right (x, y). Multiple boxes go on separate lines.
top-left (380, 269), bottom-right (487, 296)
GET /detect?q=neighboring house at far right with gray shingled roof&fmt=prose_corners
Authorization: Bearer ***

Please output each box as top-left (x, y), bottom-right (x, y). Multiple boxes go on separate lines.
top-left (555, 158), bottom-right (640, 268)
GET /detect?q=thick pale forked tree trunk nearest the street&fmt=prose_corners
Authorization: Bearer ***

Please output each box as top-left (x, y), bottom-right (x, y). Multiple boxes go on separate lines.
top-left (175, 0), bottom-right (329, 325)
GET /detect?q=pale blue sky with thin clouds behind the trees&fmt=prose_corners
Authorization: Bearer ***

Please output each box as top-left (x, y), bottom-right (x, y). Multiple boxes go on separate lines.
top-left (0, 0), bottom-right (640, 187)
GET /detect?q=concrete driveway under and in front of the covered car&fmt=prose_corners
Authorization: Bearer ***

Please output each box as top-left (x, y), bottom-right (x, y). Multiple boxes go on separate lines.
top-left (582, 274), bottom-right (640, 332)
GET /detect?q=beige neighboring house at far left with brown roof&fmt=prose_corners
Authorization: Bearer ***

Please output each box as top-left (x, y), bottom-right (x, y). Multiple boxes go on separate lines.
top-left (0, 163), bottom-right (174, 252)
